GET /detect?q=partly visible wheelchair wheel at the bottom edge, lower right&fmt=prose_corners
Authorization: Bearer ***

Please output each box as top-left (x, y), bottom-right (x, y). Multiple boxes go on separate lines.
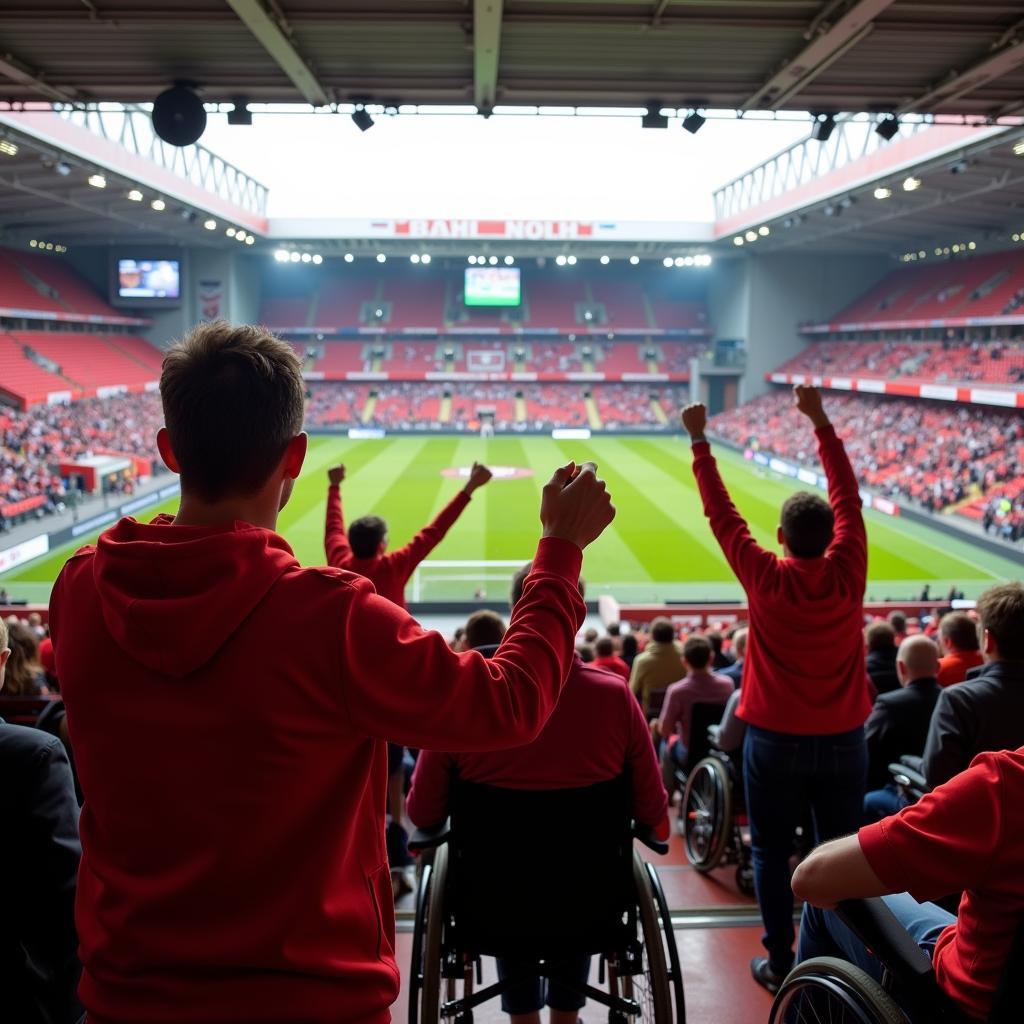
top-left (768, 956), bottom-right (907, 1024)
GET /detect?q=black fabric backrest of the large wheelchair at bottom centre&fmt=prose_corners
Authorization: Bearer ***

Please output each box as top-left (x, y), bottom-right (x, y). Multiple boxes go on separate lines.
top-left (445, 774), bottom-right (636, 958)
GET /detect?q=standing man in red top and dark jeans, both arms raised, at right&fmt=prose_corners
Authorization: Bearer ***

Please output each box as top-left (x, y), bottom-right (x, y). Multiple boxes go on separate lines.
top-left (683, 385), bottom-right (871, 991)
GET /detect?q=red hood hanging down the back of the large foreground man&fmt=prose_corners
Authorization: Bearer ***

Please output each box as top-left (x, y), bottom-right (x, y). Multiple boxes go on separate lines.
top-left (92, 515), bottom-right (298, 678)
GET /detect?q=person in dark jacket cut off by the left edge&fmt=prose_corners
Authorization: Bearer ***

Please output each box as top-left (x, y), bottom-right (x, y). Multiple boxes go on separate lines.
top-left (0, 618), bottom-right (82, 1024)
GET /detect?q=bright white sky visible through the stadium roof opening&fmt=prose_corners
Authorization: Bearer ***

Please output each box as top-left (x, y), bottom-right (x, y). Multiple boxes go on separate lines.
top-left (202, 112), bottom-right (809, 221)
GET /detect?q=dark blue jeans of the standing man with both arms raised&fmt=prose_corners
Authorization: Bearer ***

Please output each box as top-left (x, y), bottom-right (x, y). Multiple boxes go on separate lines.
top-left (743, 725), bottom-right (867, 975)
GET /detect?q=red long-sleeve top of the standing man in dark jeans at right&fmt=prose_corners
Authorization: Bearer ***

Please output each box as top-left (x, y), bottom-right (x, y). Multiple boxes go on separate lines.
top-left (693, 425), bottom-right (871, 735)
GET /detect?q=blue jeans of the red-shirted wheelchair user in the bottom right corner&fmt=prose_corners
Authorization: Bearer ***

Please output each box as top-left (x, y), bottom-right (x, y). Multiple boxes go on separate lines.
top-left (797, 893), bottom-right (956, 1024)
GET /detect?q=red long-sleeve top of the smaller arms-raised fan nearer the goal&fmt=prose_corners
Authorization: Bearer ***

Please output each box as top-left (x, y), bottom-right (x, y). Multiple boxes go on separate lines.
top-left (324, 484), bottom-right (470, 608)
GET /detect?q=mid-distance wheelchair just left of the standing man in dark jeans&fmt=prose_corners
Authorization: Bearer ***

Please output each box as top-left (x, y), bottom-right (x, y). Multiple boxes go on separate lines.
top-left (676, 703), bottom-right (754, 896)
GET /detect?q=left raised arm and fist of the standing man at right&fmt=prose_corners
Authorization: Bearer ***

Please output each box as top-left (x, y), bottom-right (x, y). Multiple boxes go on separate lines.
top-left (683, 402), bottom-right (776, 589)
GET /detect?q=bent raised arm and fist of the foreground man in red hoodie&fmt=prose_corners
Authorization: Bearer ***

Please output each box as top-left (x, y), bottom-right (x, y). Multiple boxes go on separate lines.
top-left (340, 463), bottom-right (614, 752)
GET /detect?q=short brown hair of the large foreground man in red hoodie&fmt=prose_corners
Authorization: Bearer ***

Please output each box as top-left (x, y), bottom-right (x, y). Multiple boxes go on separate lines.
top-left (160, 319), bottom-right (305, 502)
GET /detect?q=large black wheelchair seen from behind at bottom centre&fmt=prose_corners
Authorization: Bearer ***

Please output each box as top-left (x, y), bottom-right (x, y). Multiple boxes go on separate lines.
top-left (409, 775), bottom-right (686, 1024)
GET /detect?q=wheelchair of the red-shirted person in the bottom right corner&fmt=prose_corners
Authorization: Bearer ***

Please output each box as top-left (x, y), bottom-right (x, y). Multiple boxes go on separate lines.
top-left (768, 898), bottom-right (1024, 1024)
